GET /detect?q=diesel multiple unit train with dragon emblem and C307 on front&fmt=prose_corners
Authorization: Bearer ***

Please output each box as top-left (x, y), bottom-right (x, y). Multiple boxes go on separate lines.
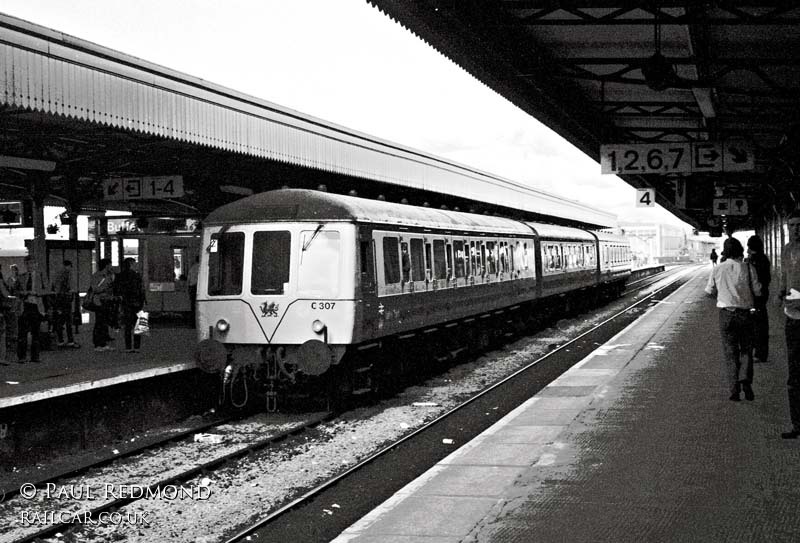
top-left (197, 189), bottom-right (631, 404)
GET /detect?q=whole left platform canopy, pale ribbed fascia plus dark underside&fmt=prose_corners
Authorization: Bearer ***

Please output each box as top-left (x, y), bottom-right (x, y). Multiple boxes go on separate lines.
top-left (0, 14), bottom-right (616, 230)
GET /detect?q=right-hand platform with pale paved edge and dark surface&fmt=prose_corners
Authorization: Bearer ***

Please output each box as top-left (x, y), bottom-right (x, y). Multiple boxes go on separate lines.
top-left (334, 267), bottom-right (800, 543)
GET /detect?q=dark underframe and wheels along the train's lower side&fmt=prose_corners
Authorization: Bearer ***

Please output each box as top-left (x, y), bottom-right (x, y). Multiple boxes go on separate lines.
top-left (220, 279), bottom-right (625, 412)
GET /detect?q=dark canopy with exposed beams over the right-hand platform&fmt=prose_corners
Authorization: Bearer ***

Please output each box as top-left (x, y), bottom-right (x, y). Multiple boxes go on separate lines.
top-left (369, 0), bottom-right (800, 236)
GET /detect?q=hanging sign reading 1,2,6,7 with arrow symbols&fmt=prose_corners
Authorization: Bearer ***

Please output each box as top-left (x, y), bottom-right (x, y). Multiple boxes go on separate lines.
top-left (600, 141), bottom-right (755, 175)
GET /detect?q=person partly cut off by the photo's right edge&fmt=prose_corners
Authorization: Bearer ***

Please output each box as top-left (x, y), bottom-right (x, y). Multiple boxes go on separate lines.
top-left (778, 210), bottom-right (800, 439)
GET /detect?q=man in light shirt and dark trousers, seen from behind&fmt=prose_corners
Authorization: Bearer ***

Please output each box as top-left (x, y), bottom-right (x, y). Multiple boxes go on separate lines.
top-left (705, 238), bottom-right (761, 402)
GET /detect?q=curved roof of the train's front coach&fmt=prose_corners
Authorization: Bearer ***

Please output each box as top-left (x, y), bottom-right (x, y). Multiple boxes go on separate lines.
top-left (204, 189), bottom-right (534, 235)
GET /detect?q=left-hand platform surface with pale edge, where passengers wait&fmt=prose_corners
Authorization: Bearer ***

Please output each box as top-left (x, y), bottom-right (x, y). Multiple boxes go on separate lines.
top-left (0, 324), bottom-right (197, 409)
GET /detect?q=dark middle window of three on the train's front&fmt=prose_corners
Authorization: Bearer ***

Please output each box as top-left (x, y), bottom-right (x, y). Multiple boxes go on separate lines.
top-left (250, 231), bottom-right (291, 294)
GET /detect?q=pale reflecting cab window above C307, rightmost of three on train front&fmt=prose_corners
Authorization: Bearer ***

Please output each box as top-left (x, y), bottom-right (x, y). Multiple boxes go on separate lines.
top-left (297, 230), bottom-right (341, 296)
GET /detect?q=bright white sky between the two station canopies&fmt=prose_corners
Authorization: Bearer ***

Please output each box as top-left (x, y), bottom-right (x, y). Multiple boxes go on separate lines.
top-left (0, 0), bottom-right (688, 228)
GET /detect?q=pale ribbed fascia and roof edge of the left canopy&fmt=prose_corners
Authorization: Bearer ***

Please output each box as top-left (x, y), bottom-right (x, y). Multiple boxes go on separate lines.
top-left (0, 14), bottom-right (615, 225)
